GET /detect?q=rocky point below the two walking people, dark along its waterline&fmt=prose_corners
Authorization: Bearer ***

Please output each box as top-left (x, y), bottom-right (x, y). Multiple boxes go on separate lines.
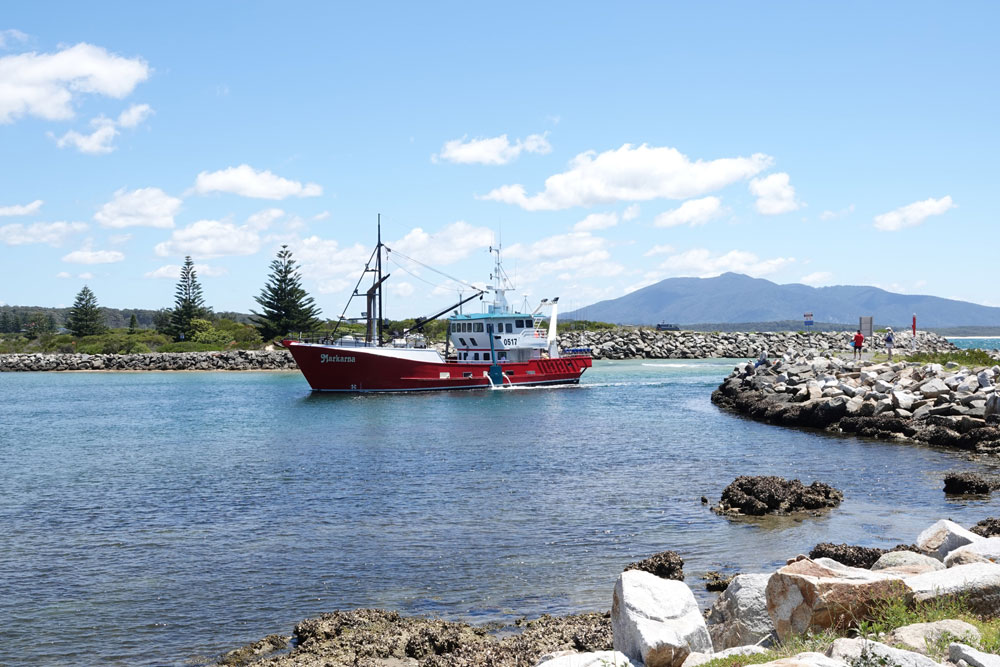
top-left (712, 351), bottom-right (1000, 451)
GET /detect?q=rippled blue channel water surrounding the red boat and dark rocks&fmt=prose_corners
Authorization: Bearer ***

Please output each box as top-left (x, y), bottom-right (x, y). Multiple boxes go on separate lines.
top-left (0, 361), bottom-right (1000, 665)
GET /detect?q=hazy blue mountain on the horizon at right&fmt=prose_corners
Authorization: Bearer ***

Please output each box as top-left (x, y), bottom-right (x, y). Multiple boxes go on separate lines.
top-left (562, 273), bottom-right (1000, 328)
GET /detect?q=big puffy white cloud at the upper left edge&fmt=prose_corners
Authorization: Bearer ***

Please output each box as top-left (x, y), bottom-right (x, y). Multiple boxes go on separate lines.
top-left (0, 43), bottom-right (150, 124)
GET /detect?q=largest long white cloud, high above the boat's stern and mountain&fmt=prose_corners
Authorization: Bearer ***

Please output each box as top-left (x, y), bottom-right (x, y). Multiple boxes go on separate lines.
top-left (479, 144), bottom-right (773, 211)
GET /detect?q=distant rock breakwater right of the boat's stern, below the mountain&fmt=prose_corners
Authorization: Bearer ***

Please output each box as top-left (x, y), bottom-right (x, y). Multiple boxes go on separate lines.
top-left (559, 327), bottom-right (956, 359)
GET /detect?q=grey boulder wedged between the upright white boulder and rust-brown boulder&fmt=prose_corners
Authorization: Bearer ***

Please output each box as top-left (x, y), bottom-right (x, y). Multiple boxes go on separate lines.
top-left (706, 574), bottom-right (774, 651)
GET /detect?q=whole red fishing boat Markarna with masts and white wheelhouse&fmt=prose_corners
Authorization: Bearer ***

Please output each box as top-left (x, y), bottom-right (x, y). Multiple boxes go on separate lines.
top-left (282, 226), bottom-right (592, 392)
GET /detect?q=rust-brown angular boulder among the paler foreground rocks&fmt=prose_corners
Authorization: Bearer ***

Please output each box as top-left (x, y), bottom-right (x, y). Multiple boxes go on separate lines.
top-left (766, 558), bottom-right (907, 641)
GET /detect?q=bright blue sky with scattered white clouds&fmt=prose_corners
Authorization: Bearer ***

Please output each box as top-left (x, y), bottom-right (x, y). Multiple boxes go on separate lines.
top-left (0, 2), bottom-right (1000, 319)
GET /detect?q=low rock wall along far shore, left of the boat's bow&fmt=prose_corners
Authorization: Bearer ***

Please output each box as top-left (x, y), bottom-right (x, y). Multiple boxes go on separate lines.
top-left (0, 350), bottom-right (298, 372)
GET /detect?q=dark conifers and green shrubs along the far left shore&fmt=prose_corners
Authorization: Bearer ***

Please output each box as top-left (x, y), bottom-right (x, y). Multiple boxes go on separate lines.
top-left (0, 246), bottom-right (321, 343)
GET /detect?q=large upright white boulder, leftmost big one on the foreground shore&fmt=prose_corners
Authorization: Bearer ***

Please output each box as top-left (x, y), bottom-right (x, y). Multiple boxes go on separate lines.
top-left (611, 570), bottom-right (713, 667)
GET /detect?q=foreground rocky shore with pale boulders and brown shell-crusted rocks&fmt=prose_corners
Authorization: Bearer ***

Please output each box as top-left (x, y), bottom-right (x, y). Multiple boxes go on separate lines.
top-left (217, 519), bottom-right (1000, 667)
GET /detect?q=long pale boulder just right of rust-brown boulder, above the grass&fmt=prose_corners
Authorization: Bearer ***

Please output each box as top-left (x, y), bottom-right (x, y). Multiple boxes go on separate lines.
top-left (905, 563), bottom-right (1000, 616)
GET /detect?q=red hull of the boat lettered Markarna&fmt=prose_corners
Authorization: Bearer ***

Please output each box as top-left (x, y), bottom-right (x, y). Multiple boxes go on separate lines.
top-left (282, 340), bottom-right (592, 392)
